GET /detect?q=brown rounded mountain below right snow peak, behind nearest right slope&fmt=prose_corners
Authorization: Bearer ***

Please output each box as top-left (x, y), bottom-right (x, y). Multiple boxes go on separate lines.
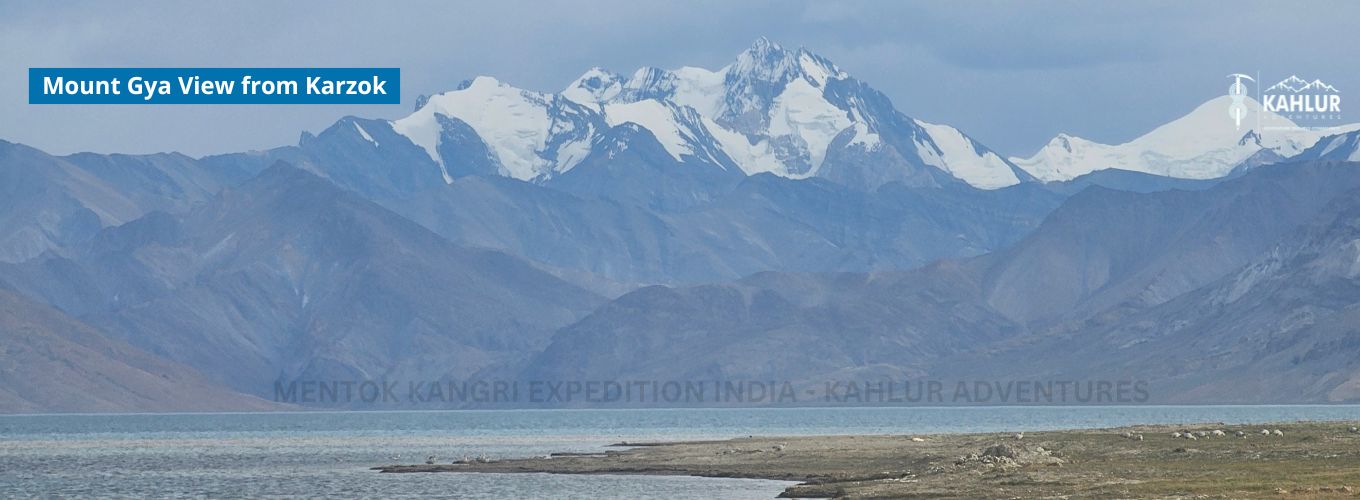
top-left (986, 158), bottom-right (1360, 322)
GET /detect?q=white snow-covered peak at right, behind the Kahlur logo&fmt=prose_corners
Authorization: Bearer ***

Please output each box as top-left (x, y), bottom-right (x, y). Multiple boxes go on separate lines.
top-left (1010, 95), bottom-right (1360, 182)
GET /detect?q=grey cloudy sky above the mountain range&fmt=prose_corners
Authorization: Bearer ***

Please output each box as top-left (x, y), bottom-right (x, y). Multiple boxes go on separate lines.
top-left (0, 0), bottom-right (1360, 156)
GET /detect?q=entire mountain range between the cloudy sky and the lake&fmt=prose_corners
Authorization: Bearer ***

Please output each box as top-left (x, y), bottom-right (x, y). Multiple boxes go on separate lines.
top-left (0, 39), bottom-right (1360, 412)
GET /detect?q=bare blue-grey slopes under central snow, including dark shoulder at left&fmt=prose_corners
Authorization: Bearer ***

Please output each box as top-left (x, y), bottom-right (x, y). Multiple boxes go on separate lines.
top-left (204, 113), bottom-right (1070, 284)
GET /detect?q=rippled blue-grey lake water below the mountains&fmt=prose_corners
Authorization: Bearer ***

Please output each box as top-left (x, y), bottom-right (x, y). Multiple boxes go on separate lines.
top-left (0, 406), bottom-right (1360, 499)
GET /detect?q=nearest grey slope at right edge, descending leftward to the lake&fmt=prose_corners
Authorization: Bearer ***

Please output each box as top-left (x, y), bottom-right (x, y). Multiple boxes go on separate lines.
top-left (937, 179), bottom-right (1360, 404)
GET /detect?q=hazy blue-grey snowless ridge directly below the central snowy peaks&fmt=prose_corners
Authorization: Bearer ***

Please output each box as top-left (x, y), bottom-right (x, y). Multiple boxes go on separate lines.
top-left (392, 169), bottom-right (1062, 284)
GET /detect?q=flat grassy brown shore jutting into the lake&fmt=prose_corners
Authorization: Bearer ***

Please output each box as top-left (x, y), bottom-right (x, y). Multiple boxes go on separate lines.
top-left (374, 423), bottom-right (1360, 499)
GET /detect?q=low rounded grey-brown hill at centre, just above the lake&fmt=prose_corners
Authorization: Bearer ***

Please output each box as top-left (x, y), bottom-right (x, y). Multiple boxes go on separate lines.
top-left (522, 262), bottom-right (1020, 383)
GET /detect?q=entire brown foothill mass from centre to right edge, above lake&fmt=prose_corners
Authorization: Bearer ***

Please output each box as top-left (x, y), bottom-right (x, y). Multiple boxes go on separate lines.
top-left (525, 163), bottom-right (1360, 402)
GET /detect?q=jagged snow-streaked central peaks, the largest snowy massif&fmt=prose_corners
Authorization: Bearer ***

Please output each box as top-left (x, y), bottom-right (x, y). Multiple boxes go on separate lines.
top-left (392, 38), bottom-right (1031, 189)
